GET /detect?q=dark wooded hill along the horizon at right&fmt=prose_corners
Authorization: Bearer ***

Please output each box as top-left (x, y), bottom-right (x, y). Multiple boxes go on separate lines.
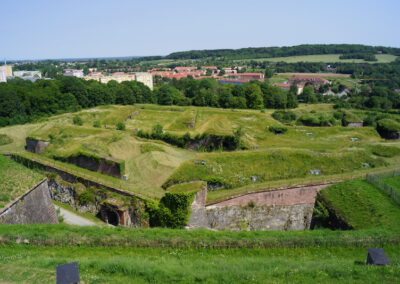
top-left (165, 44), bottom-right (400, 59)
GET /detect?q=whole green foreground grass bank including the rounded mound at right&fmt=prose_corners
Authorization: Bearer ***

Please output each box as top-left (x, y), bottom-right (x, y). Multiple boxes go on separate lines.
top-left (0, 180), bottom-right (400, 283)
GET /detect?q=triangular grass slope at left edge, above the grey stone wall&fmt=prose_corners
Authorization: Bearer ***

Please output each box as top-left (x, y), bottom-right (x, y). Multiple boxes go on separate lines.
top-left (0, 155), bottom-right (44, 208)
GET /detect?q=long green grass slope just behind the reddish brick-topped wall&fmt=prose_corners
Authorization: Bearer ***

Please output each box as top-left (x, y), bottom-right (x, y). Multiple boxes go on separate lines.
top-left (167, 150), bottom-right (384, 188)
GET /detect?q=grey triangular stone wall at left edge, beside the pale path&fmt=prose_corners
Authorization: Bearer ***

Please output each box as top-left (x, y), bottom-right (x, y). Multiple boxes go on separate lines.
top-left (0, 180), bottom-right (58, 224)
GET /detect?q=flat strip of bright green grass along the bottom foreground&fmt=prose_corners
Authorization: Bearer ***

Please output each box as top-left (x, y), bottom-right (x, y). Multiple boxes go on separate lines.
top-left (0, 245), bottom-right (400, 283)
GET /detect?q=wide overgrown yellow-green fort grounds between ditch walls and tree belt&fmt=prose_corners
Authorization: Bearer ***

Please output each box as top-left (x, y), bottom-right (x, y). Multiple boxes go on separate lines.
top-left (0, 104), bottom-right (400, 199)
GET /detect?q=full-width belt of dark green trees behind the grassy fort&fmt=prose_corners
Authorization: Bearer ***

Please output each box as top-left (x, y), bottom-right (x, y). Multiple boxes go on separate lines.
top-left (0, 73), bottom-right (400, 127)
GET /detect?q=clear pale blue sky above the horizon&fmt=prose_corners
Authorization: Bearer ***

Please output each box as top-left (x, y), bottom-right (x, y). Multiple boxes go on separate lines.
top-left (0, 0), bottom-right (400, 59)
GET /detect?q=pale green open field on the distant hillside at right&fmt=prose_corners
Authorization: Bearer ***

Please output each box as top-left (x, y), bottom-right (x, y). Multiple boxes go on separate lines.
top-left (247, 54), bottom-right (396, 63)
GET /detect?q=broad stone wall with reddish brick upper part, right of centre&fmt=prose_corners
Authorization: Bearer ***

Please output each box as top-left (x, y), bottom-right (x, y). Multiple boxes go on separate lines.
top-left (188, 184), bottom-right (329, 231)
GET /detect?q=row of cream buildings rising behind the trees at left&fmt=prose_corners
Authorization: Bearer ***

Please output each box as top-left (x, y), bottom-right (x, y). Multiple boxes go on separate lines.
top-left (64, 69), bottom-right (153, 90)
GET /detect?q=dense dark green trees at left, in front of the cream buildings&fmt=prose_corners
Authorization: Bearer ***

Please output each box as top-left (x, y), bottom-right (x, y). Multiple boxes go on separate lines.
top-left (0, 76), bottom-right (153, 127)
